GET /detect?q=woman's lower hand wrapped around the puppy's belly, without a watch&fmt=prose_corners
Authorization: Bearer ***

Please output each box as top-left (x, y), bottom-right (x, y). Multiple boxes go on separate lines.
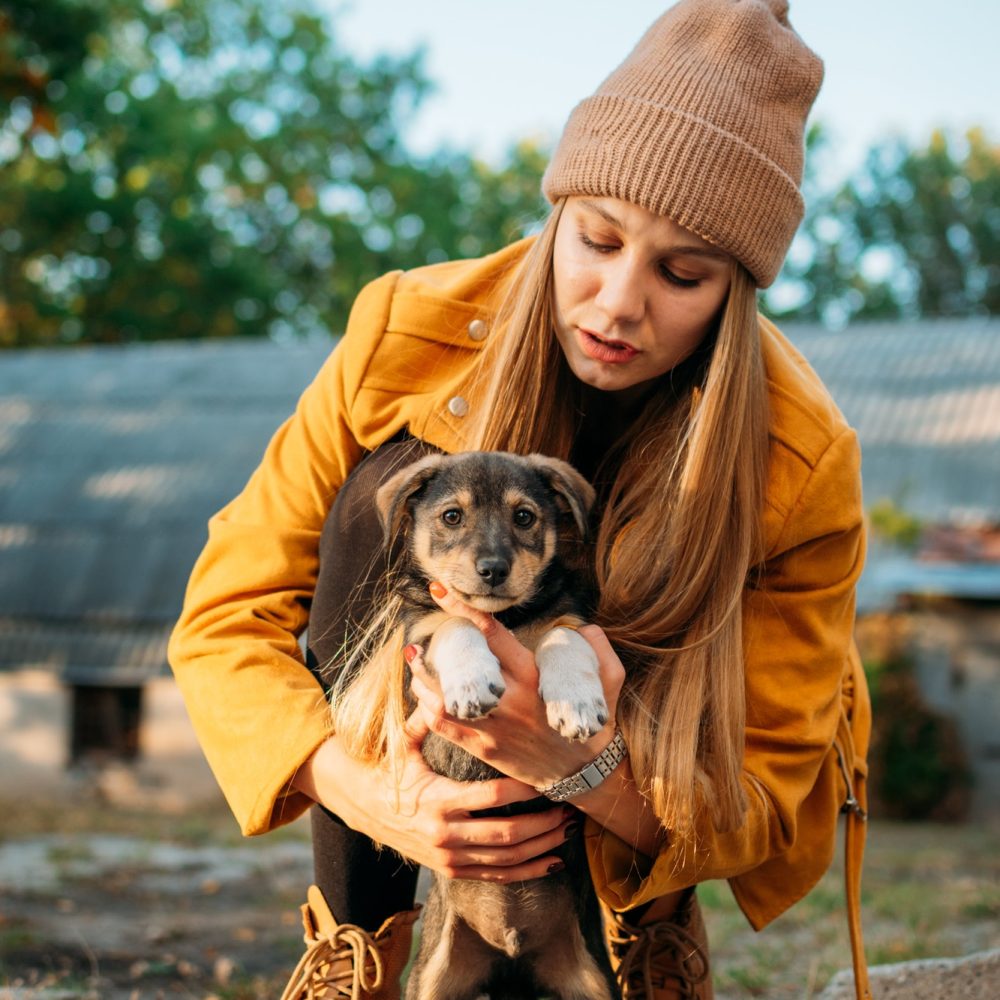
top-left (294, 711), bottom-right (577, 882)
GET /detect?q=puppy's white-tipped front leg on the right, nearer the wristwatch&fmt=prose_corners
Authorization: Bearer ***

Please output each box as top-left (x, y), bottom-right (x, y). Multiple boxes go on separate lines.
top-left (535, 625), bottom-right (608, 740)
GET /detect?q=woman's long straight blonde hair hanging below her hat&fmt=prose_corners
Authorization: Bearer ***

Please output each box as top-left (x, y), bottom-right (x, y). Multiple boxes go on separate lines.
top-left (472, 202), bottom-right (768, 835)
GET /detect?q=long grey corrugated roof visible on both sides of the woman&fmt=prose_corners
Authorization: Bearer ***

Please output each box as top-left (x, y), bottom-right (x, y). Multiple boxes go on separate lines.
top-left (0, 320), bottom-right (1000, 669)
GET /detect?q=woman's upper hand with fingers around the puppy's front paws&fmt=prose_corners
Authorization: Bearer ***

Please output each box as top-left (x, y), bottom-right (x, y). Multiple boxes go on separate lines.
top-left (407, 584), bottom-right (625, 788)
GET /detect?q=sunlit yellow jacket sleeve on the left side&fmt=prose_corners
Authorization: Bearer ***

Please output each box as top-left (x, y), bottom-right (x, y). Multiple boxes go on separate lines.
top-left (169, 273), bottom-right (398, 834)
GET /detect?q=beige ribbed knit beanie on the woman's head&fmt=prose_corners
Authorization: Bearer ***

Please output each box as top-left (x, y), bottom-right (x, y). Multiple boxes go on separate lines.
top-left (542, 0), bottom-right (823, 288)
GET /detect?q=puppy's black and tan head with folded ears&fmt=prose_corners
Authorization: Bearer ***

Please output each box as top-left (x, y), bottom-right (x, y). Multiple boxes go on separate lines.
top-left (376, 452), bottom-right (593, 612)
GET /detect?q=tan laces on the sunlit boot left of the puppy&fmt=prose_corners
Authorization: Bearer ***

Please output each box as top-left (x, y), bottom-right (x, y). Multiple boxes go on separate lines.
top-left (281, 924), bottom-right (383, 1000)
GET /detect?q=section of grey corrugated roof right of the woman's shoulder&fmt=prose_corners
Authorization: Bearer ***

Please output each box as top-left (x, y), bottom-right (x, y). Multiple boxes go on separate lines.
top-left (786, 318), bottom-right (1000, 521)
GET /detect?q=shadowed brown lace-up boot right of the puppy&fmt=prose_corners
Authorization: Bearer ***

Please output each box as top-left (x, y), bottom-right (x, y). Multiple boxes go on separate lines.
top-left (603, 889), bottom-right (715, 1000)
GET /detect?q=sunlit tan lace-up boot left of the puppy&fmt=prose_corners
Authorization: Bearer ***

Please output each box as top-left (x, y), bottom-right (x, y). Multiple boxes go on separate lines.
top-left (281, 885), bottom-right (420, 1000)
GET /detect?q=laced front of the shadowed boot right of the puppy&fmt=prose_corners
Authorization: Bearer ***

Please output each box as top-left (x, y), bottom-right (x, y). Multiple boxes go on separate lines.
top-left (609, 920), bottom-right (708, 1000)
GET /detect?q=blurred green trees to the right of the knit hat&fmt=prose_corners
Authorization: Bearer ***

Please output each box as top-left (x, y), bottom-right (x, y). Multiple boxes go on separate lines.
top-left (764, 123), bottom-right (1000, 325)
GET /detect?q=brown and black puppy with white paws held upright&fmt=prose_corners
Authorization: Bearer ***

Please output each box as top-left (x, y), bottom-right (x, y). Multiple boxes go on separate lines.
top-left (376, 452), bottom-right (618, 1000)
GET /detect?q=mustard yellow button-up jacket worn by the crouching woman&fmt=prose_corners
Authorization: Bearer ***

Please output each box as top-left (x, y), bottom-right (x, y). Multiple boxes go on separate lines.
top-left (170, 234), bottom-right (869, 928)
